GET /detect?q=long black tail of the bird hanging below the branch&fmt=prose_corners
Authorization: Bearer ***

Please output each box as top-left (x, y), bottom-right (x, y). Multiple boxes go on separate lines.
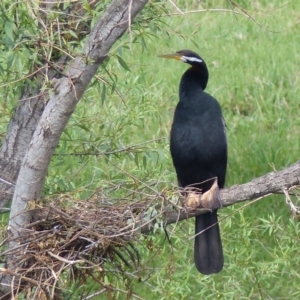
top-left (194, 210), bottom-right (224, 275)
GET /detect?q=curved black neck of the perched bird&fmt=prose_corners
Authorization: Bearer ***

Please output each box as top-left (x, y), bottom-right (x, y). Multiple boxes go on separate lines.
top-left (179, 66), bottom-right (209, 101)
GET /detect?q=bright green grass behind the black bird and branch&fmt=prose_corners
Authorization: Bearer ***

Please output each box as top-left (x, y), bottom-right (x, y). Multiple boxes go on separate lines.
top-left (1, 0), bottom-right (300, 299)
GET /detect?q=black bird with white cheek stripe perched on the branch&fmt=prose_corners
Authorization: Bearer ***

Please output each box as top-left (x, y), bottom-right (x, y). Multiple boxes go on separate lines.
top-left (160, 50), bottom-right (227, 275)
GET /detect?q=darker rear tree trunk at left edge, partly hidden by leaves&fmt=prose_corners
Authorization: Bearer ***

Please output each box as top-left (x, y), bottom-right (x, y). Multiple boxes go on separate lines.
top-left (0, 0), bottom-right (97, 213)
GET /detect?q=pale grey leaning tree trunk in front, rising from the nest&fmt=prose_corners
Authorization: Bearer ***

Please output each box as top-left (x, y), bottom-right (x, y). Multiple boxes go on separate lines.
top-left (0, 0), bottom-right (148, 297)
